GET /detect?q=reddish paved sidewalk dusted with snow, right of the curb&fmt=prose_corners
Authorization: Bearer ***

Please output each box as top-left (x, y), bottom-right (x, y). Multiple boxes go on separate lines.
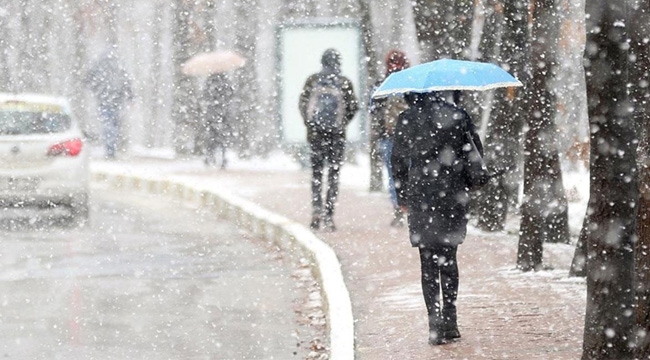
top-left (105, 160), bottom-right (586, 360)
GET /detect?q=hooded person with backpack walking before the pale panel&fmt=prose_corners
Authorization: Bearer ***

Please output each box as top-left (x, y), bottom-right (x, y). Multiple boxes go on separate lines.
top-left (298, 49), bottom-right (358, 231)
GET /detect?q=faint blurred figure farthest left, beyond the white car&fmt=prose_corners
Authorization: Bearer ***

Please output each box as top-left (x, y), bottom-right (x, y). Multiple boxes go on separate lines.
top-left (85, 50), bottom-right (133, 159)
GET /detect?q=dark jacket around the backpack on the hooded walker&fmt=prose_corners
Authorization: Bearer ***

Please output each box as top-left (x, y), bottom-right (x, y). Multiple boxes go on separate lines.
top-left (298, 63), bottom-right (359, 141)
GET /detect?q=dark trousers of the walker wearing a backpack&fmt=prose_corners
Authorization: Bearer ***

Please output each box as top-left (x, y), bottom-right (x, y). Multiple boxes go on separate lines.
top-left (309, 133), bottom-right (345, 217)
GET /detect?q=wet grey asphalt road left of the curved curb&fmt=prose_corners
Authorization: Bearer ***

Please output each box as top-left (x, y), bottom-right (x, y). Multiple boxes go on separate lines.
top-left (0, 184), bottom-right (308, 360)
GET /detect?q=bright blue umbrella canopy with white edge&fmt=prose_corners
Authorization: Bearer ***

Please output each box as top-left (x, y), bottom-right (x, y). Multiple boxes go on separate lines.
top-left (372, 59), bottom-right (522, 98)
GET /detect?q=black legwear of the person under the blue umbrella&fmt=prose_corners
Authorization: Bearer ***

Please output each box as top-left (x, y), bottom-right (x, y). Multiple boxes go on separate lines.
top-left (420, 246), bottom-right (458, 322)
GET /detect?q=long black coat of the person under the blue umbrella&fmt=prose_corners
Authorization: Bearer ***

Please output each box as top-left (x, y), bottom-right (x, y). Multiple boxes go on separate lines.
top-left (391, 95), bottom-right (483, 247)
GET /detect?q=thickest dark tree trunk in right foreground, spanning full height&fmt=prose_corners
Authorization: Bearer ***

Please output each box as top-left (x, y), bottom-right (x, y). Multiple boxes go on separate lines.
top-left (582, 0), bottom-right (638, 360)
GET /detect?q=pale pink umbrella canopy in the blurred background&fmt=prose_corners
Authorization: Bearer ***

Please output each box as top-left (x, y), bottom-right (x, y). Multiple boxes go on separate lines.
top-left (181, 50), bottom-right (246, 76)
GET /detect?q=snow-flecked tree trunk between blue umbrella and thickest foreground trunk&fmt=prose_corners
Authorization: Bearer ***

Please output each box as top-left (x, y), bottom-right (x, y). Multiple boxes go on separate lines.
top-left (517, 0), bottom-right (569, 271)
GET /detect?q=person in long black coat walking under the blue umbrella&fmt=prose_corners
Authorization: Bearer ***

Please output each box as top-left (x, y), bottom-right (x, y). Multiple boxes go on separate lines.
top-left (391, 92), bottom-right (484, 345)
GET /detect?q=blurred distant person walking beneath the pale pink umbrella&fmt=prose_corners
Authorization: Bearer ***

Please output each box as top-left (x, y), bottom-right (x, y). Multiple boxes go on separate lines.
top-left (203, 73), bottom-right (234, 169)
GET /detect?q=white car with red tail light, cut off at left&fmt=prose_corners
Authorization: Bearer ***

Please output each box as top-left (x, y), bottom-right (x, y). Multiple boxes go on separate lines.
top-left (0, 93), bottom-right (90, 223)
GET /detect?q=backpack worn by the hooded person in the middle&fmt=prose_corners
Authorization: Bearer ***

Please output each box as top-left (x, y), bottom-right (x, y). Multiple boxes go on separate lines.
top-left (307, 75), bottom-right (345, 132)
